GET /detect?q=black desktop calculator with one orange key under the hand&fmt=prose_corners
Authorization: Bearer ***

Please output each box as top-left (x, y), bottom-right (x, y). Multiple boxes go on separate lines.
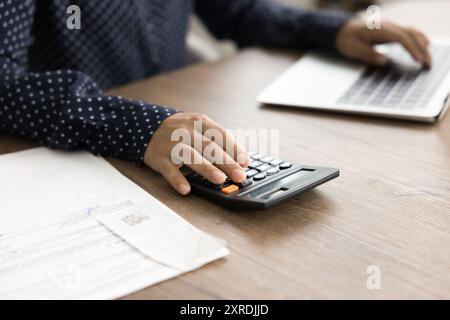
top-left (187, 152), bottom-right (339, 210)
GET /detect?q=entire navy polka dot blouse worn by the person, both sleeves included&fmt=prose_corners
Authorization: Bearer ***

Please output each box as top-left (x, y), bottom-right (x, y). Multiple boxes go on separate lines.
top-left (0, 0), bottom-right (348, 163)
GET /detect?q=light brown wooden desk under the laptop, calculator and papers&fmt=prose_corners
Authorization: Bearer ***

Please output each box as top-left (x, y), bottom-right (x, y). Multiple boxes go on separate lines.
top-left (0, 1), bottom-right (450, 299)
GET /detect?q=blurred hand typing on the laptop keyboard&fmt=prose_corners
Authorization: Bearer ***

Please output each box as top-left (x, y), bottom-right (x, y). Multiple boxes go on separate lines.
top-left (336, 18), bottom-right (431, 67)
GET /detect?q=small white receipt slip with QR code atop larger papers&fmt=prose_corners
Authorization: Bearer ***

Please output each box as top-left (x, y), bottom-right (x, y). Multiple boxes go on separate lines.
top-left (98, 201), bottom-right (229, 272)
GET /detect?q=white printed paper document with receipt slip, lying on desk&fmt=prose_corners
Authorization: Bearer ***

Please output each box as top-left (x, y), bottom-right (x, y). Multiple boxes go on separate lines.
top-left (0, 148), bottom-right (228, 299)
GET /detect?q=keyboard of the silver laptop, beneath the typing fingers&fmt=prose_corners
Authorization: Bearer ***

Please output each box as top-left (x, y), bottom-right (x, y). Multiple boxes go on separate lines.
top-left (338, 45), bottom-right (450, 110)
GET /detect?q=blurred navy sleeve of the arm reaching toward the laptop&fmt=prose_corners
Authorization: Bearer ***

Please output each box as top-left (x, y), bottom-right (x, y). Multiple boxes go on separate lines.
top-left (196, 0), bottom-right (352, 51)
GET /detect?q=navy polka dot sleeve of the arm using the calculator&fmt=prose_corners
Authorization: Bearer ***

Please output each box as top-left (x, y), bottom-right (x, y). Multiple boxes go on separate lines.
top-left (0, 0), bottom-right (176, 163)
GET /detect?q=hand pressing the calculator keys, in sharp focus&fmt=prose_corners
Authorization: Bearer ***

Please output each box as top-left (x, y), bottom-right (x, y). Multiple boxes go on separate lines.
top-left (144, 113), bottom-right (249, 195)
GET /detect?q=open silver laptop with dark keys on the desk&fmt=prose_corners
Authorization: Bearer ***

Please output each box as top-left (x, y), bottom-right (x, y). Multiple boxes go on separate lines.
top-left (258, 38), bottom-right (450, 122)
